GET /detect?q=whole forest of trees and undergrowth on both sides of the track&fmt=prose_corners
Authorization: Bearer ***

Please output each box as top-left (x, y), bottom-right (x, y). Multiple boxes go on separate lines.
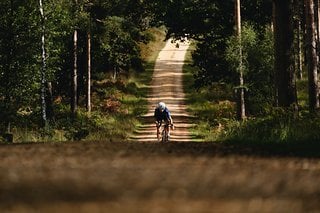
top-left (0, 0), bottom-right (320, 142)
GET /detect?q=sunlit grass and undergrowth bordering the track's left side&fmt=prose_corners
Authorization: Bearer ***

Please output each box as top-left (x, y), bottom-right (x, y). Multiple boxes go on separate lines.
top-left (0, 27), bottom-right (165, 142)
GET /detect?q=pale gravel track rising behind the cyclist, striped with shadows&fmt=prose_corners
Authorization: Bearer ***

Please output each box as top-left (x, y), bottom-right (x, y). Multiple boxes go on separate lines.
top-left (131, 39), bottom-right (195, 142)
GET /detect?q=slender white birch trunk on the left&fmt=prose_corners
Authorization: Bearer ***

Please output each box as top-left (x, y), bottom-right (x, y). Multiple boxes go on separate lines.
top-left (39, 0), bottom-right (47, 126)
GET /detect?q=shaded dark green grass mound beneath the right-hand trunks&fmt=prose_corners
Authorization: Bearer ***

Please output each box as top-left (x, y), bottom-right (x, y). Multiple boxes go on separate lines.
top-left (221, 109), bottom-right (320, 143)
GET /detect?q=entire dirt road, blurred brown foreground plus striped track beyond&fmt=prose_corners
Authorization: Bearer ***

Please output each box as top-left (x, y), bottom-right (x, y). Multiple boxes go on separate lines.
top-left (0, 40), bottom-right (320, 213)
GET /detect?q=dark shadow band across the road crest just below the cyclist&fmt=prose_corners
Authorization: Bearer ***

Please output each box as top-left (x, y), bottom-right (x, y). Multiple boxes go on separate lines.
top-left (0, 140), bottom-right (320, 158)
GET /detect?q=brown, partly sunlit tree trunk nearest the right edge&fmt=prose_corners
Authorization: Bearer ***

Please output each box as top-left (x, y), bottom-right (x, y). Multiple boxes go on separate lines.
top-left (305, 0), bottom-right (319, 112)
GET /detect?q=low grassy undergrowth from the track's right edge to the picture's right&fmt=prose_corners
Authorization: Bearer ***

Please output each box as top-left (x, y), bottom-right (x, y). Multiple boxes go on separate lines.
top-left (184, 41), bottom-right (320, 147)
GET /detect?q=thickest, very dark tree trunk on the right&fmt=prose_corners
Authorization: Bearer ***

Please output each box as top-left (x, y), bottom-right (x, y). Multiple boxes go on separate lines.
top-left (273, 0), bottom-right (297, 107)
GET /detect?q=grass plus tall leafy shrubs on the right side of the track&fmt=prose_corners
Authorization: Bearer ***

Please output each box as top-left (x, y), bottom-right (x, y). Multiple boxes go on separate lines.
top-left (184, 25), bottom-right (320, 144)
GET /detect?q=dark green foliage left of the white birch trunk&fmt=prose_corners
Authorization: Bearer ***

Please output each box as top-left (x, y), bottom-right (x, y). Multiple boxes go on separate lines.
top-left (0, 1), bottom-right (40, 113)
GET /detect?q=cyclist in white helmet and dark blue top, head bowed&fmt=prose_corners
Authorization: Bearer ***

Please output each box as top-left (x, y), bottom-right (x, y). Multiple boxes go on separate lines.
top-left (154, 102), bottom-right (173, 140)
